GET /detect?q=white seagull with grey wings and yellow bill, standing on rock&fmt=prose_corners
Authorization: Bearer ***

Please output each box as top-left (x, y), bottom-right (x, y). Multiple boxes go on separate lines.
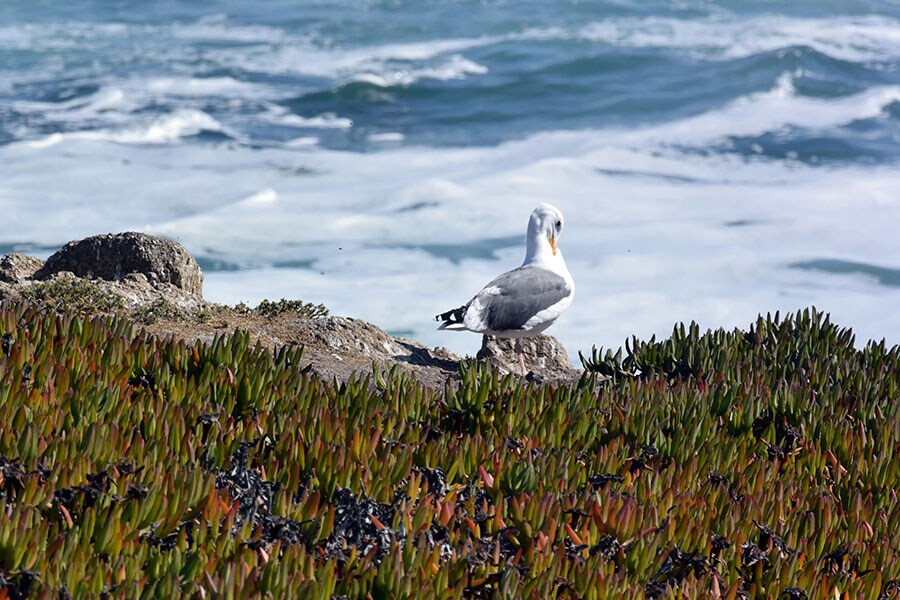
top-left (435, 203), bottom-right (575, 376)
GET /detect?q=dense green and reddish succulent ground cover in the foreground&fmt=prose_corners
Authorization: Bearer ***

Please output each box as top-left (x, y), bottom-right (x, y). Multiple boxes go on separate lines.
top-left (0, 304), bottom-right (900, 600)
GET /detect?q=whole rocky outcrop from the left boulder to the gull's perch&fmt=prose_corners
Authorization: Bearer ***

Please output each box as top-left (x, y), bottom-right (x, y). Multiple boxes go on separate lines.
top-left (0, 233), bottom-right (580, 391)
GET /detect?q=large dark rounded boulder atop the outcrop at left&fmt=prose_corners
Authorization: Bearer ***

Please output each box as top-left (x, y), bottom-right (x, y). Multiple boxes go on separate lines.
top-left (34, 231), bottom-right (203, 296)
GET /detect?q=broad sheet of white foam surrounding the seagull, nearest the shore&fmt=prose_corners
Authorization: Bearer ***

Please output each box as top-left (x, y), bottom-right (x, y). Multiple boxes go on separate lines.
top-left (7, 86), bottom-right (900, 353)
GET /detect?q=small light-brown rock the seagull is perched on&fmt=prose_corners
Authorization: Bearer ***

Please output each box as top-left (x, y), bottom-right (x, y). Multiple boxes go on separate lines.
top-left (476, 335), bottom-right (578, 378)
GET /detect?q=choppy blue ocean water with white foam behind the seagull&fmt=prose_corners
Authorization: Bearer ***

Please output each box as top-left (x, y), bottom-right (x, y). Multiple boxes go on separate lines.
top-left (0, 0), bottom-right (900, 356)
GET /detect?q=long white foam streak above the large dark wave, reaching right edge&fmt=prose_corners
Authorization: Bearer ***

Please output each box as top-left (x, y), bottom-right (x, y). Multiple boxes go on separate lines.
top-left (202, 11), bottom-right (900, 85)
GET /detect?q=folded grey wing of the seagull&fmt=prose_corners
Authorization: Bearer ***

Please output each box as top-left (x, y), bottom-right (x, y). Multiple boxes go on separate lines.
top-left (476, 267), bottom-right (570, 331)
